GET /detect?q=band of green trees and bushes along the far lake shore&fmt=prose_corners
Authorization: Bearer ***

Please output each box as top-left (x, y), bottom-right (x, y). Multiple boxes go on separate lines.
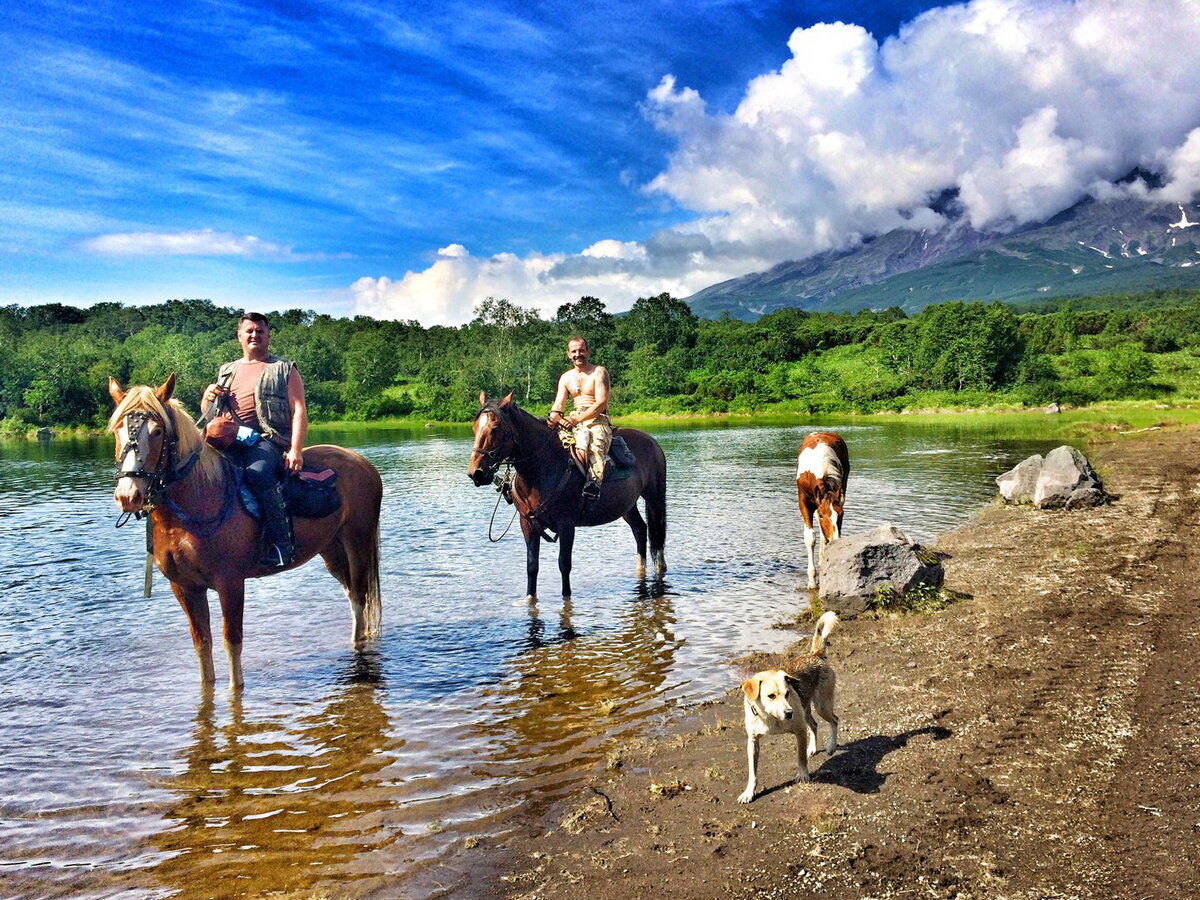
top-left (7, 290), bottom-right (1200, 434)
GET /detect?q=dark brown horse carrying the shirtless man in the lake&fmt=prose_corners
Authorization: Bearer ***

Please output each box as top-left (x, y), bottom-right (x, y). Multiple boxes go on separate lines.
top-left (467, 392), bottom-right (667, 602)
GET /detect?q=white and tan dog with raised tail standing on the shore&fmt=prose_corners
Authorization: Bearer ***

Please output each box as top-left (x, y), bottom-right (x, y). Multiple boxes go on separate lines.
top-left (738, 612), bottom-right (838, 803)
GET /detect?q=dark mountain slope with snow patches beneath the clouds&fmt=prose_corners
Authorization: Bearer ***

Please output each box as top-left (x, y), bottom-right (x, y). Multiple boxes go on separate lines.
top-left (688, 194), bottom-right (1200, 319)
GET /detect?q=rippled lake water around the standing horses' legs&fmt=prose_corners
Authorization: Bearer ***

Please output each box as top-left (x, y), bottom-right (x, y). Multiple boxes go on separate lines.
top-left (0, 420), bottom-right (1061, 898)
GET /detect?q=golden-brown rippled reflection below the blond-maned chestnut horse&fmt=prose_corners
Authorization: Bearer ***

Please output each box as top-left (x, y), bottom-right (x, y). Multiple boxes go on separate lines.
top-left (151, 653), bottom-right (404, 898)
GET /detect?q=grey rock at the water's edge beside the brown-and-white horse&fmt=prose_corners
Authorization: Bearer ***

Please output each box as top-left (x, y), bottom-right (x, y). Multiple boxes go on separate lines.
top-left (817, 526), bottom-right (946, 617)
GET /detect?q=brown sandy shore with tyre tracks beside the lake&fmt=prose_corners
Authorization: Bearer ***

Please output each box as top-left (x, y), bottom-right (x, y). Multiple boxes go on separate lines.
top-left (432, 427), bottom-right (1200, 900)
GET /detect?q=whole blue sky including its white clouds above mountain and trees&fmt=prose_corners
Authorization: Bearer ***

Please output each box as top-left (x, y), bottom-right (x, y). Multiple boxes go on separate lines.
top-left (7, 0), bottom-right (1200, 324)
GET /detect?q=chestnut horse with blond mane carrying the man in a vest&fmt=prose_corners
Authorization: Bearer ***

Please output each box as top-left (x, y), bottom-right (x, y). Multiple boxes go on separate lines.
top-left (108, 374), bottom-right (383, 688)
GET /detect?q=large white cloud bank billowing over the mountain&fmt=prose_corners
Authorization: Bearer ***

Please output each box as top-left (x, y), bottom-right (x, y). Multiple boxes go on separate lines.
top-left (353, 0), bottom-right (1200, 324)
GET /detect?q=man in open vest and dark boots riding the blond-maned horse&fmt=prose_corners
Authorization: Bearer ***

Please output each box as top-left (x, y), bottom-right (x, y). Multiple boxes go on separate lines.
top-left (202, 312), bottom-right (308, 569)
